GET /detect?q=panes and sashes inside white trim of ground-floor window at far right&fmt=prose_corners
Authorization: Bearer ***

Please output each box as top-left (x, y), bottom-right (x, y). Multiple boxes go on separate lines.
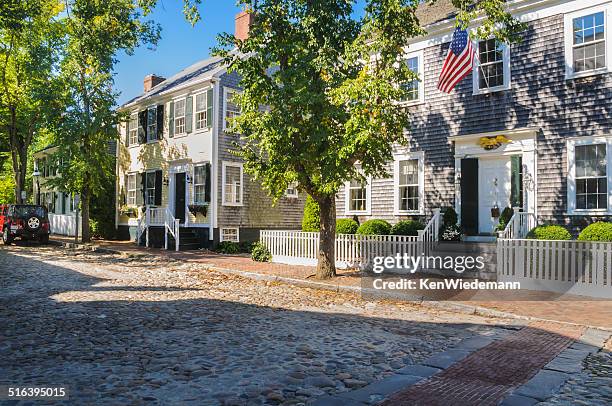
top-left (574, 144), bottom-right (608, 210)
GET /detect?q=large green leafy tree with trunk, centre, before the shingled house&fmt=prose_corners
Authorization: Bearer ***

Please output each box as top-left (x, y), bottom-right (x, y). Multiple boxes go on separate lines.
top-left (218, 0), bottom-right (519, 279)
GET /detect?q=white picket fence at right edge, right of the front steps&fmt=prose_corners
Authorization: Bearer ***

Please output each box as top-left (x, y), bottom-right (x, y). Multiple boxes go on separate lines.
top-left (497, 239), bottom-right (612, 299)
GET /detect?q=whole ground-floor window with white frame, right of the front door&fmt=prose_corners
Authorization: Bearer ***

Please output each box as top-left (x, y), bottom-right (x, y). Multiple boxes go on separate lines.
top-left (567, 137), bottom-right (612, 214)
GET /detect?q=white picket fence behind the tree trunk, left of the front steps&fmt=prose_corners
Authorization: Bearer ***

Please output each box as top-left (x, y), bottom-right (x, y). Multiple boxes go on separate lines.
top-left (259, 230), bottom-right (422, 268)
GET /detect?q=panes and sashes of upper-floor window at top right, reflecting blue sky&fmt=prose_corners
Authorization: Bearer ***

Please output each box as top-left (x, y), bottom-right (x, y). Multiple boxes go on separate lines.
top-left (572, 11), bottom-right (606, 73)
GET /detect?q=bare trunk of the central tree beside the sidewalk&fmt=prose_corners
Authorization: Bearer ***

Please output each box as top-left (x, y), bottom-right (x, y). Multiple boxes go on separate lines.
top-left (317, 195), bottom-right (336, 279)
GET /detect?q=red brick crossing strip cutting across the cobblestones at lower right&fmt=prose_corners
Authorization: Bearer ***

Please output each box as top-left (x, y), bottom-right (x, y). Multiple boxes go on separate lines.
top-left (383, 322), bottom-right (584, 406)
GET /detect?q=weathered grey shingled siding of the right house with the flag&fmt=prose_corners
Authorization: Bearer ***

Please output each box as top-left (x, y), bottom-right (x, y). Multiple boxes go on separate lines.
top-left (337, 15), bottom-right (612, 232)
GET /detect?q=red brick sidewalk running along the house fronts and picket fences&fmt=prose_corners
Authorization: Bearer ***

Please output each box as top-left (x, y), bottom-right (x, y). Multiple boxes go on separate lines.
top-left (52, 236), bottom-right (612, 329)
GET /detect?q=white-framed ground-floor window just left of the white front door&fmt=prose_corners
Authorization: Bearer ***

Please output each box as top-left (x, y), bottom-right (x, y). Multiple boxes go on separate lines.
top-left (393, 152), bottom-right (425, 215)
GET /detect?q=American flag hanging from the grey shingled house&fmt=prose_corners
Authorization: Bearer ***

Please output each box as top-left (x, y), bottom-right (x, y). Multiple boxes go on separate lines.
top-left (438, 28), bottom-right (474, 93)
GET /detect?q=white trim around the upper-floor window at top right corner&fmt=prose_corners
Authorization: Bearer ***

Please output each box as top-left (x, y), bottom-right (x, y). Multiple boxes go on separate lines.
top-left (563, 3), bottom-right (612, 80)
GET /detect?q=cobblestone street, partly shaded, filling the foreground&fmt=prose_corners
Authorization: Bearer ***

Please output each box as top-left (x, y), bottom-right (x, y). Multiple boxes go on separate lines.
top-left (0, 246), bottom-right (612, 405)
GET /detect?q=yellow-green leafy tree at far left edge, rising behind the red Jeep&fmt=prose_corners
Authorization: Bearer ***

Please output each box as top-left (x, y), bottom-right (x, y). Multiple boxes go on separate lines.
top-left (0, 0), bottom-right (62, 203)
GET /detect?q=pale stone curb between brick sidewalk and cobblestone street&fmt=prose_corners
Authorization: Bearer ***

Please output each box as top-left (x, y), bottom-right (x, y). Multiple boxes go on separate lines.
top-left (50, 241), bottom-right (612, 331)
